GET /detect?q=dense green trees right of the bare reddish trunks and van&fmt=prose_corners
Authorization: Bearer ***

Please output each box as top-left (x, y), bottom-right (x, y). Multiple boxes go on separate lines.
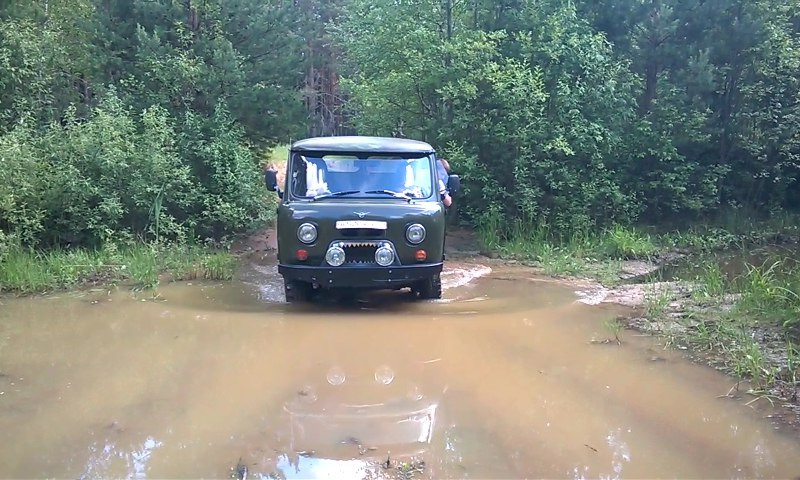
top-left (335, 0), bottom-right (800, 232)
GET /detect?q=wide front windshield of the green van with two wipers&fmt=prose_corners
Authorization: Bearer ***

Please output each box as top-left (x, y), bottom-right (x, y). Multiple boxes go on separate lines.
top-left (290, 153), bottom-right (434, 198)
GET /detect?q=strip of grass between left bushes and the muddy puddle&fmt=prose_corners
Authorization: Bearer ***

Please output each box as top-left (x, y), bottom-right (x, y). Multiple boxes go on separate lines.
top-left (0, 244), bottom-right (236, 294)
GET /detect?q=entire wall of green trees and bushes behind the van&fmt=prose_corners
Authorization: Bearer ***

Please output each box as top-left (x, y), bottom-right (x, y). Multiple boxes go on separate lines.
top-left (0, 0), bottom-right (800, 251)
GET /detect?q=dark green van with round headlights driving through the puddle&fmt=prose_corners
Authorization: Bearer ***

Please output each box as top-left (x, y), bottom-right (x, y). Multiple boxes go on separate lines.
top-left (265, 137), bottom-right (460, 302)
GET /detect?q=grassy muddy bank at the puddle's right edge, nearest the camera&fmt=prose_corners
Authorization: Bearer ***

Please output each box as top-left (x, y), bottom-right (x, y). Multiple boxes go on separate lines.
top-left (664, 253), bottom-right (800, 396)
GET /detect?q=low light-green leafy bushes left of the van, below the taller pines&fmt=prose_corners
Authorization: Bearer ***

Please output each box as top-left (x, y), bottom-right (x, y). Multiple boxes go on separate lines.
top-left (0, 94), bottom-right (267, 246)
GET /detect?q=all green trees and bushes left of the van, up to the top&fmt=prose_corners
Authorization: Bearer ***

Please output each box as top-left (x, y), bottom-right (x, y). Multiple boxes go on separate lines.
top-left (0, 0), bottom-right (303, 248)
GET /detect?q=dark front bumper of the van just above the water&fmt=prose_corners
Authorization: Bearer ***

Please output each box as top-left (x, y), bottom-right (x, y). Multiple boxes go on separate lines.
top-left (278, 263), bottom-right (442, 289)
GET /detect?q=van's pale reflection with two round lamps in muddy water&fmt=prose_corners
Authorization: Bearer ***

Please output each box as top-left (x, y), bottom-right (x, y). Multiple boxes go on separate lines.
top-left (268, 356), bottom-right (447, 478)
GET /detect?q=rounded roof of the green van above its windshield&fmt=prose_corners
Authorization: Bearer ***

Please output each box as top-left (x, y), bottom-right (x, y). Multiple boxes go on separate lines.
top-left (292, 136), bottom-right (435, 154)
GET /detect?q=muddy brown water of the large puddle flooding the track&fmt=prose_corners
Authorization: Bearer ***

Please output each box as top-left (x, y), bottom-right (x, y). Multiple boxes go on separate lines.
top-left (0, 264), bottom-right (800, 478)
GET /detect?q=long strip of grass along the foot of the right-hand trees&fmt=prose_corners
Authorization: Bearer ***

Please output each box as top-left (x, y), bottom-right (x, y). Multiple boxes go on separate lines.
top-left (476, 206), bottom-right (800, 284)
